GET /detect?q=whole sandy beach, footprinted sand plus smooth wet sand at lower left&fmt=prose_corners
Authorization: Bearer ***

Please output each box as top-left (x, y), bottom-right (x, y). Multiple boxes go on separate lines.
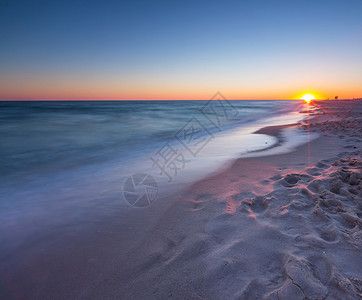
top-left (0, 100), bottom-right (362, 299)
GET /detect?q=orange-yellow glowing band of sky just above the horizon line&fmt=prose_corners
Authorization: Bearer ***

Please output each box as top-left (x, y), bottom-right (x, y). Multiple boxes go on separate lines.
top-left (0, 76), bottom-right (362, 100)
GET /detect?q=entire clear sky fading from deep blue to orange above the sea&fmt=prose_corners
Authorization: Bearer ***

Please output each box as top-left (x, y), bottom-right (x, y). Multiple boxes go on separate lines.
top-left (0, 0), bottom-right (362, 100)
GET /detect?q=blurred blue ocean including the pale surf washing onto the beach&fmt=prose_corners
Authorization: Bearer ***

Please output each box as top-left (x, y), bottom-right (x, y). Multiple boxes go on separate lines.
top-left (0, 100), bottom-right (316, 250)
